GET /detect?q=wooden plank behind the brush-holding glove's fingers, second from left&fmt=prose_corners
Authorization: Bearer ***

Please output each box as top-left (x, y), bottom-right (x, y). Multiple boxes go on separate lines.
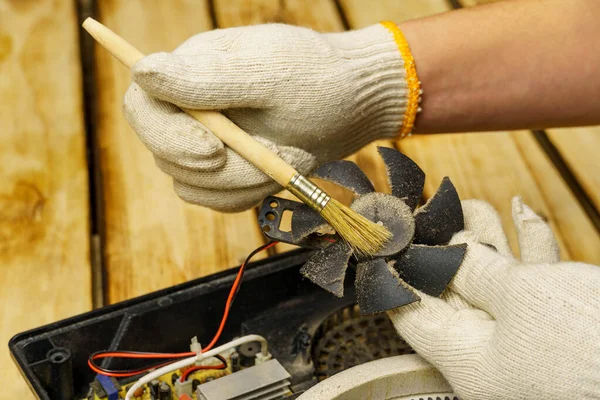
top-left (96, 0), bottom-right (264, 302)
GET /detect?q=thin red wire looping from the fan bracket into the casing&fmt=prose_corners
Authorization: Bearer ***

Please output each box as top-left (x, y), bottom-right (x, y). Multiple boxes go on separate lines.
top-left (88, 242), bottom-right (278, 382)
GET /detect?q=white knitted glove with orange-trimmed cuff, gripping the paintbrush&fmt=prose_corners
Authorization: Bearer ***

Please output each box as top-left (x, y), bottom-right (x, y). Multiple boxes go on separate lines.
top-left (124, 24), bottom-right (407, 212)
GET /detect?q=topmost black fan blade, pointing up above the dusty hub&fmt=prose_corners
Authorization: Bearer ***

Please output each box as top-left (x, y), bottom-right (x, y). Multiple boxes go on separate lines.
top-left (377, 147), bottom-right (425, 211)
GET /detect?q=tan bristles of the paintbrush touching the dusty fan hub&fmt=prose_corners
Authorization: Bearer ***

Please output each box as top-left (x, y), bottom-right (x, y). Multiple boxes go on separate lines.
top-left (321, 199), bottom-right (392, 256)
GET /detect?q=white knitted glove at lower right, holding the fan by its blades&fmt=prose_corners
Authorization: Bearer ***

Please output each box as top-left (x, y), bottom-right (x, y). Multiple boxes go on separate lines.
top-left (389, 198), bottom-right (600, 400)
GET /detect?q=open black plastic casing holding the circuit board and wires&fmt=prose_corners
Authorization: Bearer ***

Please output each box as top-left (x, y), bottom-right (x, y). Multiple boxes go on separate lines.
top-left (9, 250), bottom-right (356, 400)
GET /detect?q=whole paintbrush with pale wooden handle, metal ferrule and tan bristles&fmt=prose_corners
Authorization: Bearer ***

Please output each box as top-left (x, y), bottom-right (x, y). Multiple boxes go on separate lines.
top-left (83, 18), bottom-right (392, 256)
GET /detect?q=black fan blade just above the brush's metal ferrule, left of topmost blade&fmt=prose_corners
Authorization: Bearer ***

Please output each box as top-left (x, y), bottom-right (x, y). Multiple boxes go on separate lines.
top-left (311, 160), bottom-right (375, 195)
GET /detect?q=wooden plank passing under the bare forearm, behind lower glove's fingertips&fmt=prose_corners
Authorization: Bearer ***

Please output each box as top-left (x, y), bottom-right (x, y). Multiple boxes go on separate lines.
top-left (341, 0), bottom-right (600, 263)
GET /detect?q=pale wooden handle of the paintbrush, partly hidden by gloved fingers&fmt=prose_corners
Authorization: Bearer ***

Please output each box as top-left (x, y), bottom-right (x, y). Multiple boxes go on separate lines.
top-left (83, 18), bottom-right (297, 187)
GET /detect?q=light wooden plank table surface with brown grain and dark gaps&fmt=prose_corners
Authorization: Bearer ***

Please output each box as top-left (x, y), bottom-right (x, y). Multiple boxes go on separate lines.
top-left (0, 0), bottom-right (600, 399)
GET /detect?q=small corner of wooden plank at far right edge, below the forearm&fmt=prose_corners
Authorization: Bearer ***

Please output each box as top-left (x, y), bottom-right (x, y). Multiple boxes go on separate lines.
top-left (547, 126), bottom-right (600, 214)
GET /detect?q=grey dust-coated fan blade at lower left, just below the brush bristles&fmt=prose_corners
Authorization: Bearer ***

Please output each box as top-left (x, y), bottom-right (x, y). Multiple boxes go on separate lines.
top-left (300, 241), bottom-right (352, 297)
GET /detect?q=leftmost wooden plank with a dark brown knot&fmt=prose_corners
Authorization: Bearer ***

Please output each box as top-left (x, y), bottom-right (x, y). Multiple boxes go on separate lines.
top-left (0, 0), bottom-right (92, 399)
